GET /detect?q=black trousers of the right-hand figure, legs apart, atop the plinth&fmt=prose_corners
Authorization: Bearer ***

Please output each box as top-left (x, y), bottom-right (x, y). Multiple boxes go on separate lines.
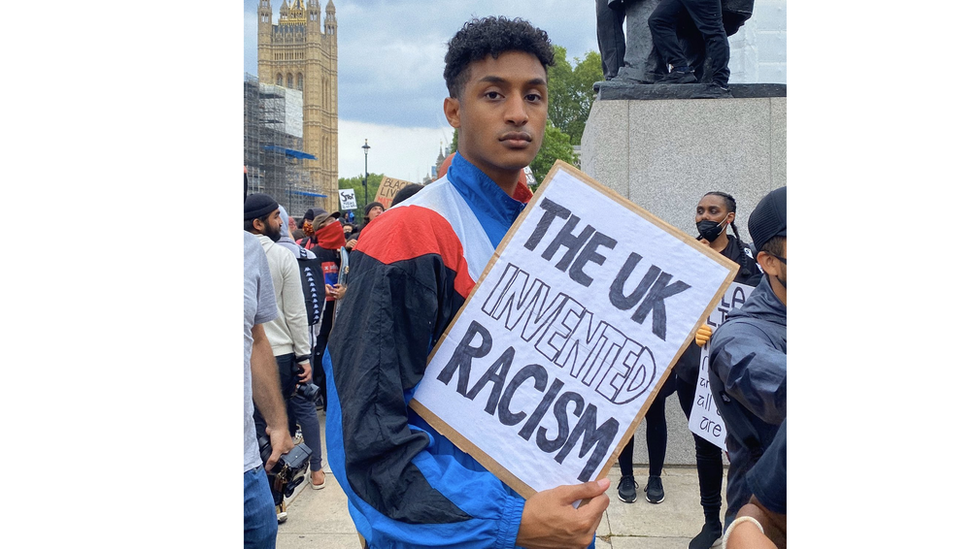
top-left (647, 0), bottom-right (729, 87)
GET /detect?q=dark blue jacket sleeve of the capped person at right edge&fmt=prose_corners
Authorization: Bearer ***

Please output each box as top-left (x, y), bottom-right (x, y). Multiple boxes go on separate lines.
top-left (710, 321), bottom-right (786, 425)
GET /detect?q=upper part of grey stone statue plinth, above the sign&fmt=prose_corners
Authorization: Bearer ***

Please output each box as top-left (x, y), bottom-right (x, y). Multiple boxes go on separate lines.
top-left (580, 88), bottom-right (786, 256)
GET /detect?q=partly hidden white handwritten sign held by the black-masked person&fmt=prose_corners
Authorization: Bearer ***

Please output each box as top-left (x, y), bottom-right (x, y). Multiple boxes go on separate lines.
top-left (688, 282), bottom-right (753, 450)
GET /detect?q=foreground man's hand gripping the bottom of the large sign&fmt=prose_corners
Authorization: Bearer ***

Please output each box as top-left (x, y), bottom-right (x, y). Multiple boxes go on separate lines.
top-left (515, 478), bottom-right (610, 549)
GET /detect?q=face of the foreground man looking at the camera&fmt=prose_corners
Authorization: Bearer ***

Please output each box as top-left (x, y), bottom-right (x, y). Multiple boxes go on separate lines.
top-left (444, 51), bottom-right (549, 188)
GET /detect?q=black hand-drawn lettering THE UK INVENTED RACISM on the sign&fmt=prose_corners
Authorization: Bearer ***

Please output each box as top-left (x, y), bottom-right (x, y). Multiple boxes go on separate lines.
top-left (437, 199), bottom-right (690, 482)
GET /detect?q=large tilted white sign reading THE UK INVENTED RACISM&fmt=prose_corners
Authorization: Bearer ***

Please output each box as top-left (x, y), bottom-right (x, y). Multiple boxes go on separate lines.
top-left (410, 162), bottom-right (736, 497)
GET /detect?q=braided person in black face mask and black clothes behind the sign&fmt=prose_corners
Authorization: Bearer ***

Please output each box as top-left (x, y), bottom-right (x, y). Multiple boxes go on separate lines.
top-left (617, 191), bottom-right (762, 549)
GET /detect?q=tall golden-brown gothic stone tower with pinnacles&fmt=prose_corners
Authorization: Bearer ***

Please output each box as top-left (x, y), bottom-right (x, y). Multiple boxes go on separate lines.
top-left (258, 0), bottom-right (339, 211)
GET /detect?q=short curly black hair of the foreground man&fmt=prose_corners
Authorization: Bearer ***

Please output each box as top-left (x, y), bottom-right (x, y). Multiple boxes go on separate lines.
top-left (444, 16), bottom-right (554, 98)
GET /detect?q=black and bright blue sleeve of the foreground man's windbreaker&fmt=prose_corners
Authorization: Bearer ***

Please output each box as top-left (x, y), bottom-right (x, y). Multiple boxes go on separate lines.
top-left (326, 251), bottom-right (525, 548)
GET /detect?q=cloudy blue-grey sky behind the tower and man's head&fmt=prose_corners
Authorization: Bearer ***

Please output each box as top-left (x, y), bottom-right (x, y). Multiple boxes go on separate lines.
top-left (244, 0), bottom-right (598, 181)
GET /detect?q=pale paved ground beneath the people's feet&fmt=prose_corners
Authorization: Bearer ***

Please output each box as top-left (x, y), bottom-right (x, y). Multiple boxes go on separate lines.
top-left (278, 404), bottom-right (725, 549)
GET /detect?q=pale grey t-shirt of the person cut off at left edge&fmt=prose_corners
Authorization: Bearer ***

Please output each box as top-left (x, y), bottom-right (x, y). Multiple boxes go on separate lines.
top-left (243, 231), bottom-right (278, 472)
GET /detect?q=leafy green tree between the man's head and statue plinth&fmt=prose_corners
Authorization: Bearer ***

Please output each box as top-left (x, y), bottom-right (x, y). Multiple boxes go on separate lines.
top-left (549, 45), bottom-right (603, 145)
